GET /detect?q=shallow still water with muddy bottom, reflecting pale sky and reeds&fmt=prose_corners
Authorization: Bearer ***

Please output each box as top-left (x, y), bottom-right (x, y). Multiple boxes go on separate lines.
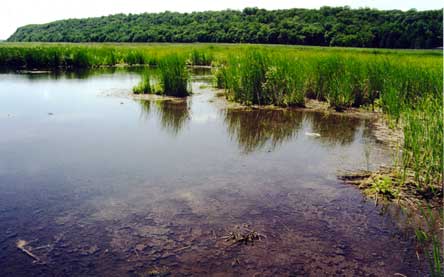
top-left (0, 69), bottom-right (426, 276)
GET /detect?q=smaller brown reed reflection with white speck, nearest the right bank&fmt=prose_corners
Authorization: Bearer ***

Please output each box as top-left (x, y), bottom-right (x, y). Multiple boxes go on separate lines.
top-left (305, 113), bottom-right (361, 145)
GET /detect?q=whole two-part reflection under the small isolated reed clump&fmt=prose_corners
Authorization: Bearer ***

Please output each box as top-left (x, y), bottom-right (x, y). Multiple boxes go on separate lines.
top-left (139, 99), bottom-right (190, 135)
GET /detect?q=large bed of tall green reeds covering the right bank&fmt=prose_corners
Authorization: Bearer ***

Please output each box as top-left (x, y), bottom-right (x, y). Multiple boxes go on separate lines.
top-left (215, 47), bottom-right (443, 192)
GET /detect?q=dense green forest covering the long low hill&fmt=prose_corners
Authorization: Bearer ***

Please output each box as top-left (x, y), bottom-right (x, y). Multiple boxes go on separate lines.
top-left (9, 7), bottom-right (443, 48)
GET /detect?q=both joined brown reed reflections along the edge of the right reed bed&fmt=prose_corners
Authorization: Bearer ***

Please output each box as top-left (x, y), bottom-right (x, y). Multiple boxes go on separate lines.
top-left (224, 109), bottom-right (370, 153)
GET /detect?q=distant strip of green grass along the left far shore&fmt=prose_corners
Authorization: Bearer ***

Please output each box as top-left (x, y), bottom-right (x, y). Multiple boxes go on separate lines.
top-left (0, 43), bottom-right (220, 69)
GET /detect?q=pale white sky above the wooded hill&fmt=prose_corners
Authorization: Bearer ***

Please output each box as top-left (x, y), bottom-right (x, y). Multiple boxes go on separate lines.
top-left (0, 0), bottom-right (444, 40)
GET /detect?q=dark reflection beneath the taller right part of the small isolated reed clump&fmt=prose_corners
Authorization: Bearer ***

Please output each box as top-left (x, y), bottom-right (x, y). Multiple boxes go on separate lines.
top-left (156, 100), bottom-right (190, 135)
